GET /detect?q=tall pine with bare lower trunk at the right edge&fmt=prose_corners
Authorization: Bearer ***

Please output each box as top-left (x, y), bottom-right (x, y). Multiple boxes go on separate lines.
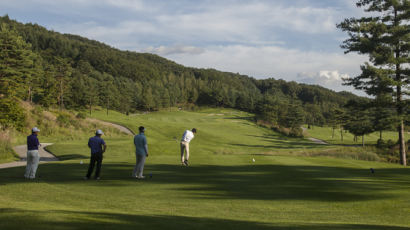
top-left (338, 0), bottom-right (410, 165)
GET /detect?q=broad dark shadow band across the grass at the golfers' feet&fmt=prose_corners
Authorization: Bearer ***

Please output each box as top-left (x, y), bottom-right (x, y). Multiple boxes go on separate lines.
top-left (0, 163), bottom-right (410, 202)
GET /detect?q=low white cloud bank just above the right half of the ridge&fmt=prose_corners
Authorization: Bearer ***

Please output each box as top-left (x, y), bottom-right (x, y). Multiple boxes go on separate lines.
top-left (158, 45), bottom-right (366, 91)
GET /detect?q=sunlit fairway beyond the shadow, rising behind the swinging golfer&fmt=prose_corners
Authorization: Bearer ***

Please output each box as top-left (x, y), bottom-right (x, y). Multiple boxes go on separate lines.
top-left (93, 109), bottom-right (323, 154)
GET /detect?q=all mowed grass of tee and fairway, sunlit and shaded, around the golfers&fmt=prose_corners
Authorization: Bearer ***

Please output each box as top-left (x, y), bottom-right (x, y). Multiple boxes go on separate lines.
top-left (0, 110), bottom-right (410, 230)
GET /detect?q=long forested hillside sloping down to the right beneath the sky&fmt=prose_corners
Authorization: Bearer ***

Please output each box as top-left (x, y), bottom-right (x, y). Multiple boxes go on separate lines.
top-left (0, 16), bottom-right (358, 131)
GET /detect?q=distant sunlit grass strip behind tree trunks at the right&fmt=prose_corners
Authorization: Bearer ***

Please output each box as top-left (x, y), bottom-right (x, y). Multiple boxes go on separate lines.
top-left (306, 126), bottom-right (410, 145)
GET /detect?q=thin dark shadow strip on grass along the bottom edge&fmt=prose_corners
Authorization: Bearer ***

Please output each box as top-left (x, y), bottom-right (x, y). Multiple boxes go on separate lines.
top-left (0, 208), bottom-right (410, 230)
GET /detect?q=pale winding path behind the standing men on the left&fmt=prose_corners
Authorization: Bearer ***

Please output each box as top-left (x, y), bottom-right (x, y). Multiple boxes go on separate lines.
top-left (0, 118), bottom-right (135, 169)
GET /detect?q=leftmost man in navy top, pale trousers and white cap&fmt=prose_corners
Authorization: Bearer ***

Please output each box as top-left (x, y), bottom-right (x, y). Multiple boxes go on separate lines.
top-left (24, 127), bottom-right (41, 179)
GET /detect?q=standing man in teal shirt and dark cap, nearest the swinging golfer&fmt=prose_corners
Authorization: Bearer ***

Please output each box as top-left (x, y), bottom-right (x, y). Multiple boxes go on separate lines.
top-left (132, 126), bottom-right (148, 179)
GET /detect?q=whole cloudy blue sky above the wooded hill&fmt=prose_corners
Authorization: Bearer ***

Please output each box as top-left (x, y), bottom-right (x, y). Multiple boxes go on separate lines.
top-left (0, 0), bottom-right (367, 94)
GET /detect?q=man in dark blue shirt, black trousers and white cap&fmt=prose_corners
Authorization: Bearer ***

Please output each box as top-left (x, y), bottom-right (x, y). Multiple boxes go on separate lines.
top-left (84, 130), bottom-right (107, 180)
